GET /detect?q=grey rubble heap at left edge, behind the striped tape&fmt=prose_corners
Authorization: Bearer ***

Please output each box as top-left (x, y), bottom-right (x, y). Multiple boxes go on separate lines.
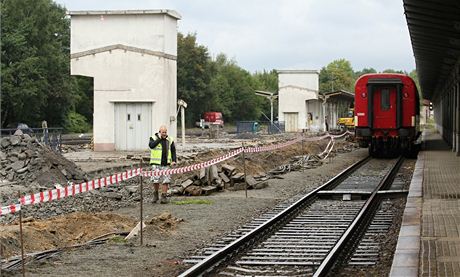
top-left (0, 134), bottom-right (87, 205)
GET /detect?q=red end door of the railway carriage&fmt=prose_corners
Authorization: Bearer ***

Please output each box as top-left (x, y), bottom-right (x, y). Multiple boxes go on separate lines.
top-left (373, 86), bottom-right (396, 129)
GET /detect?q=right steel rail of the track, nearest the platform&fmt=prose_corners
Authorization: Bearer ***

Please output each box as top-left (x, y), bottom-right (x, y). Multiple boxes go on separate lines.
top-left (313, 156), bottom-right (404, 277)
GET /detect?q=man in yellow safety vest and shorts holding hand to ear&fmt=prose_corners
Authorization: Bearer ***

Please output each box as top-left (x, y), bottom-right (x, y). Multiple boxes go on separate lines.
top-left (149, 125), bottom-right (176, 204)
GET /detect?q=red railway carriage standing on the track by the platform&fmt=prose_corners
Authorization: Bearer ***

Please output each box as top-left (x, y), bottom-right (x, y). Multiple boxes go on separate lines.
top-left (355, 73), bottom-right (420, 157)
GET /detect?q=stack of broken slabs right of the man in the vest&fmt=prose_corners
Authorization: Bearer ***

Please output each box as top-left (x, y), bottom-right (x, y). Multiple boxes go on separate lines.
top-left (171, 164), bottom-right (268, 196)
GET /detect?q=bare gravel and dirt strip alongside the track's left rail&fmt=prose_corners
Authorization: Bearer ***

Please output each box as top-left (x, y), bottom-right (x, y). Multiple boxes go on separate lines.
top-left (1, 149), bottom-right (367, 276)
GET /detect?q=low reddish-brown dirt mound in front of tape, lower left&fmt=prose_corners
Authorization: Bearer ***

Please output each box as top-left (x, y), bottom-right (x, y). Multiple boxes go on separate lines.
top-left (0, 213), bottom-right (136, 258)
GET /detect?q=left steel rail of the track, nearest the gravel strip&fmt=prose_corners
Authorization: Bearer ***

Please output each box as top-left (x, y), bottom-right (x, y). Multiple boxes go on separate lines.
top-left (179, 156), bottom-right (371, 277)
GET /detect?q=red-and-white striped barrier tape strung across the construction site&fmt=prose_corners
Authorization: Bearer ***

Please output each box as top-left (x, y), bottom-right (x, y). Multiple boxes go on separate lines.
top-left (0, 131), bottom-right (351, 216)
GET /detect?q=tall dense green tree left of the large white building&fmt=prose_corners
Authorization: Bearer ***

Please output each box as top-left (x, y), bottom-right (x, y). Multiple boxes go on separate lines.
top-left (0, 0), bottom-right (71, 126)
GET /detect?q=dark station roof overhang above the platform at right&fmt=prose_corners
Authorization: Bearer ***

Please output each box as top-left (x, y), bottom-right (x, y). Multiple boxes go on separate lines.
top-left (403, 0), bottom-right (460, 100)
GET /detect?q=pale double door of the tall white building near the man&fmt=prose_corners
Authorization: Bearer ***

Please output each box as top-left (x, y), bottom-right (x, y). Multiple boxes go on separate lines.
top-left (115, 103), bottom-right (152, 150)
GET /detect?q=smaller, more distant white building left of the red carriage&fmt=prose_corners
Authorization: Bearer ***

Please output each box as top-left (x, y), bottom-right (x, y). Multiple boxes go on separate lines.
top-left (277, 70), bottom-right (324, 132)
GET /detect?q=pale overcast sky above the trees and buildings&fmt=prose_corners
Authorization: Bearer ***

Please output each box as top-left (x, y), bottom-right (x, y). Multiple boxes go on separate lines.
top-left (55, 0), bottom-right (415, 72)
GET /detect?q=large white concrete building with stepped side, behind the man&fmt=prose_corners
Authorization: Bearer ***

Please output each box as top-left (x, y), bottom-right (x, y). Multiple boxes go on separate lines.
top-left (69, 10), bottom-right (181, 151)
